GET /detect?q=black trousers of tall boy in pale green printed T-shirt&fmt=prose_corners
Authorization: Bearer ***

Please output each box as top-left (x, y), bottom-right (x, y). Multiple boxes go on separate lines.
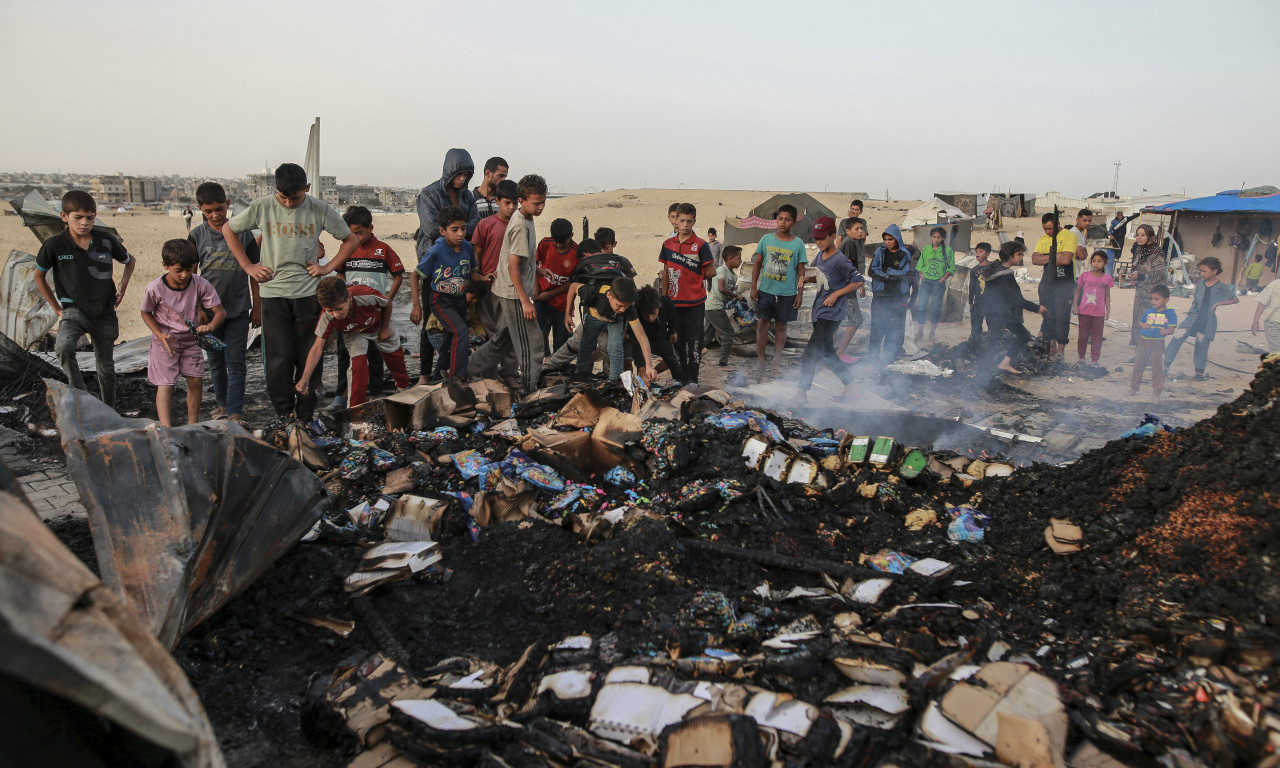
top-left (262, 296), bottom-right (324, 421)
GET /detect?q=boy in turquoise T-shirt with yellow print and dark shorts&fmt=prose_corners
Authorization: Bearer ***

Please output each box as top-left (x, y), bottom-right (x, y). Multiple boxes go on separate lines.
top-left (751, 205), bottom-right (808, 379)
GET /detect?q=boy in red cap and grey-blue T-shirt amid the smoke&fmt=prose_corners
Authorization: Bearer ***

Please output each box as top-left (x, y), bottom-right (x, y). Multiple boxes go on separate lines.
top-left (796, 216), bottom-right (863, 403)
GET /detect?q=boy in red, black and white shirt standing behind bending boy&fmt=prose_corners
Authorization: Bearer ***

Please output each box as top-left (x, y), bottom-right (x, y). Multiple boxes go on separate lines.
top-left (325, 205), bottom-right (404, 411)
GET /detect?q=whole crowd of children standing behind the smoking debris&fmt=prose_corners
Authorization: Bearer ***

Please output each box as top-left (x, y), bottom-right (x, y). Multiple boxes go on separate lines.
top-left (37, 177), bottom-right (1280, 425)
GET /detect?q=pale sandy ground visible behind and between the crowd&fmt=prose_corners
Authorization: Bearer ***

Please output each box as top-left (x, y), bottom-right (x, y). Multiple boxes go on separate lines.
top-left (0, 189), bottom-right (1263, 422)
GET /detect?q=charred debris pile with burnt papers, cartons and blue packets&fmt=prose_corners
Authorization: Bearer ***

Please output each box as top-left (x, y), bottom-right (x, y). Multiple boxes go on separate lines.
top-left (40, 356), bottom-right (1280, 767)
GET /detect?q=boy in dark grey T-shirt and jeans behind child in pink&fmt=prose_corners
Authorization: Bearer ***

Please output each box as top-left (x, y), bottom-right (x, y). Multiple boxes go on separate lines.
top-left (187, 182), bottom-right (262, 421)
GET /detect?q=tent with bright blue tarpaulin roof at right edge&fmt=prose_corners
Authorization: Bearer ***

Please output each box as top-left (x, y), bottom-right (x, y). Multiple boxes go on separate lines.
top-left (1142, 187), bottom-right (1280, 284)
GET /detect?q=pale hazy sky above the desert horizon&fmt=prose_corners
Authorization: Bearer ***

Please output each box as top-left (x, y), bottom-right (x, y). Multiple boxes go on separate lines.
top-left (0, 0), bottom-right (1280, 198)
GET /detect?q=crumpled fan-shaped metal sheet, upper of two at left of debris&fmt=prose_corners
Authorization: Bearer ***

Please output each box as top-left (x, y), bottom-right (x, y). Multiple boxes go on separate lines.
top-left (46, 381), bottom-right (330, 648)
